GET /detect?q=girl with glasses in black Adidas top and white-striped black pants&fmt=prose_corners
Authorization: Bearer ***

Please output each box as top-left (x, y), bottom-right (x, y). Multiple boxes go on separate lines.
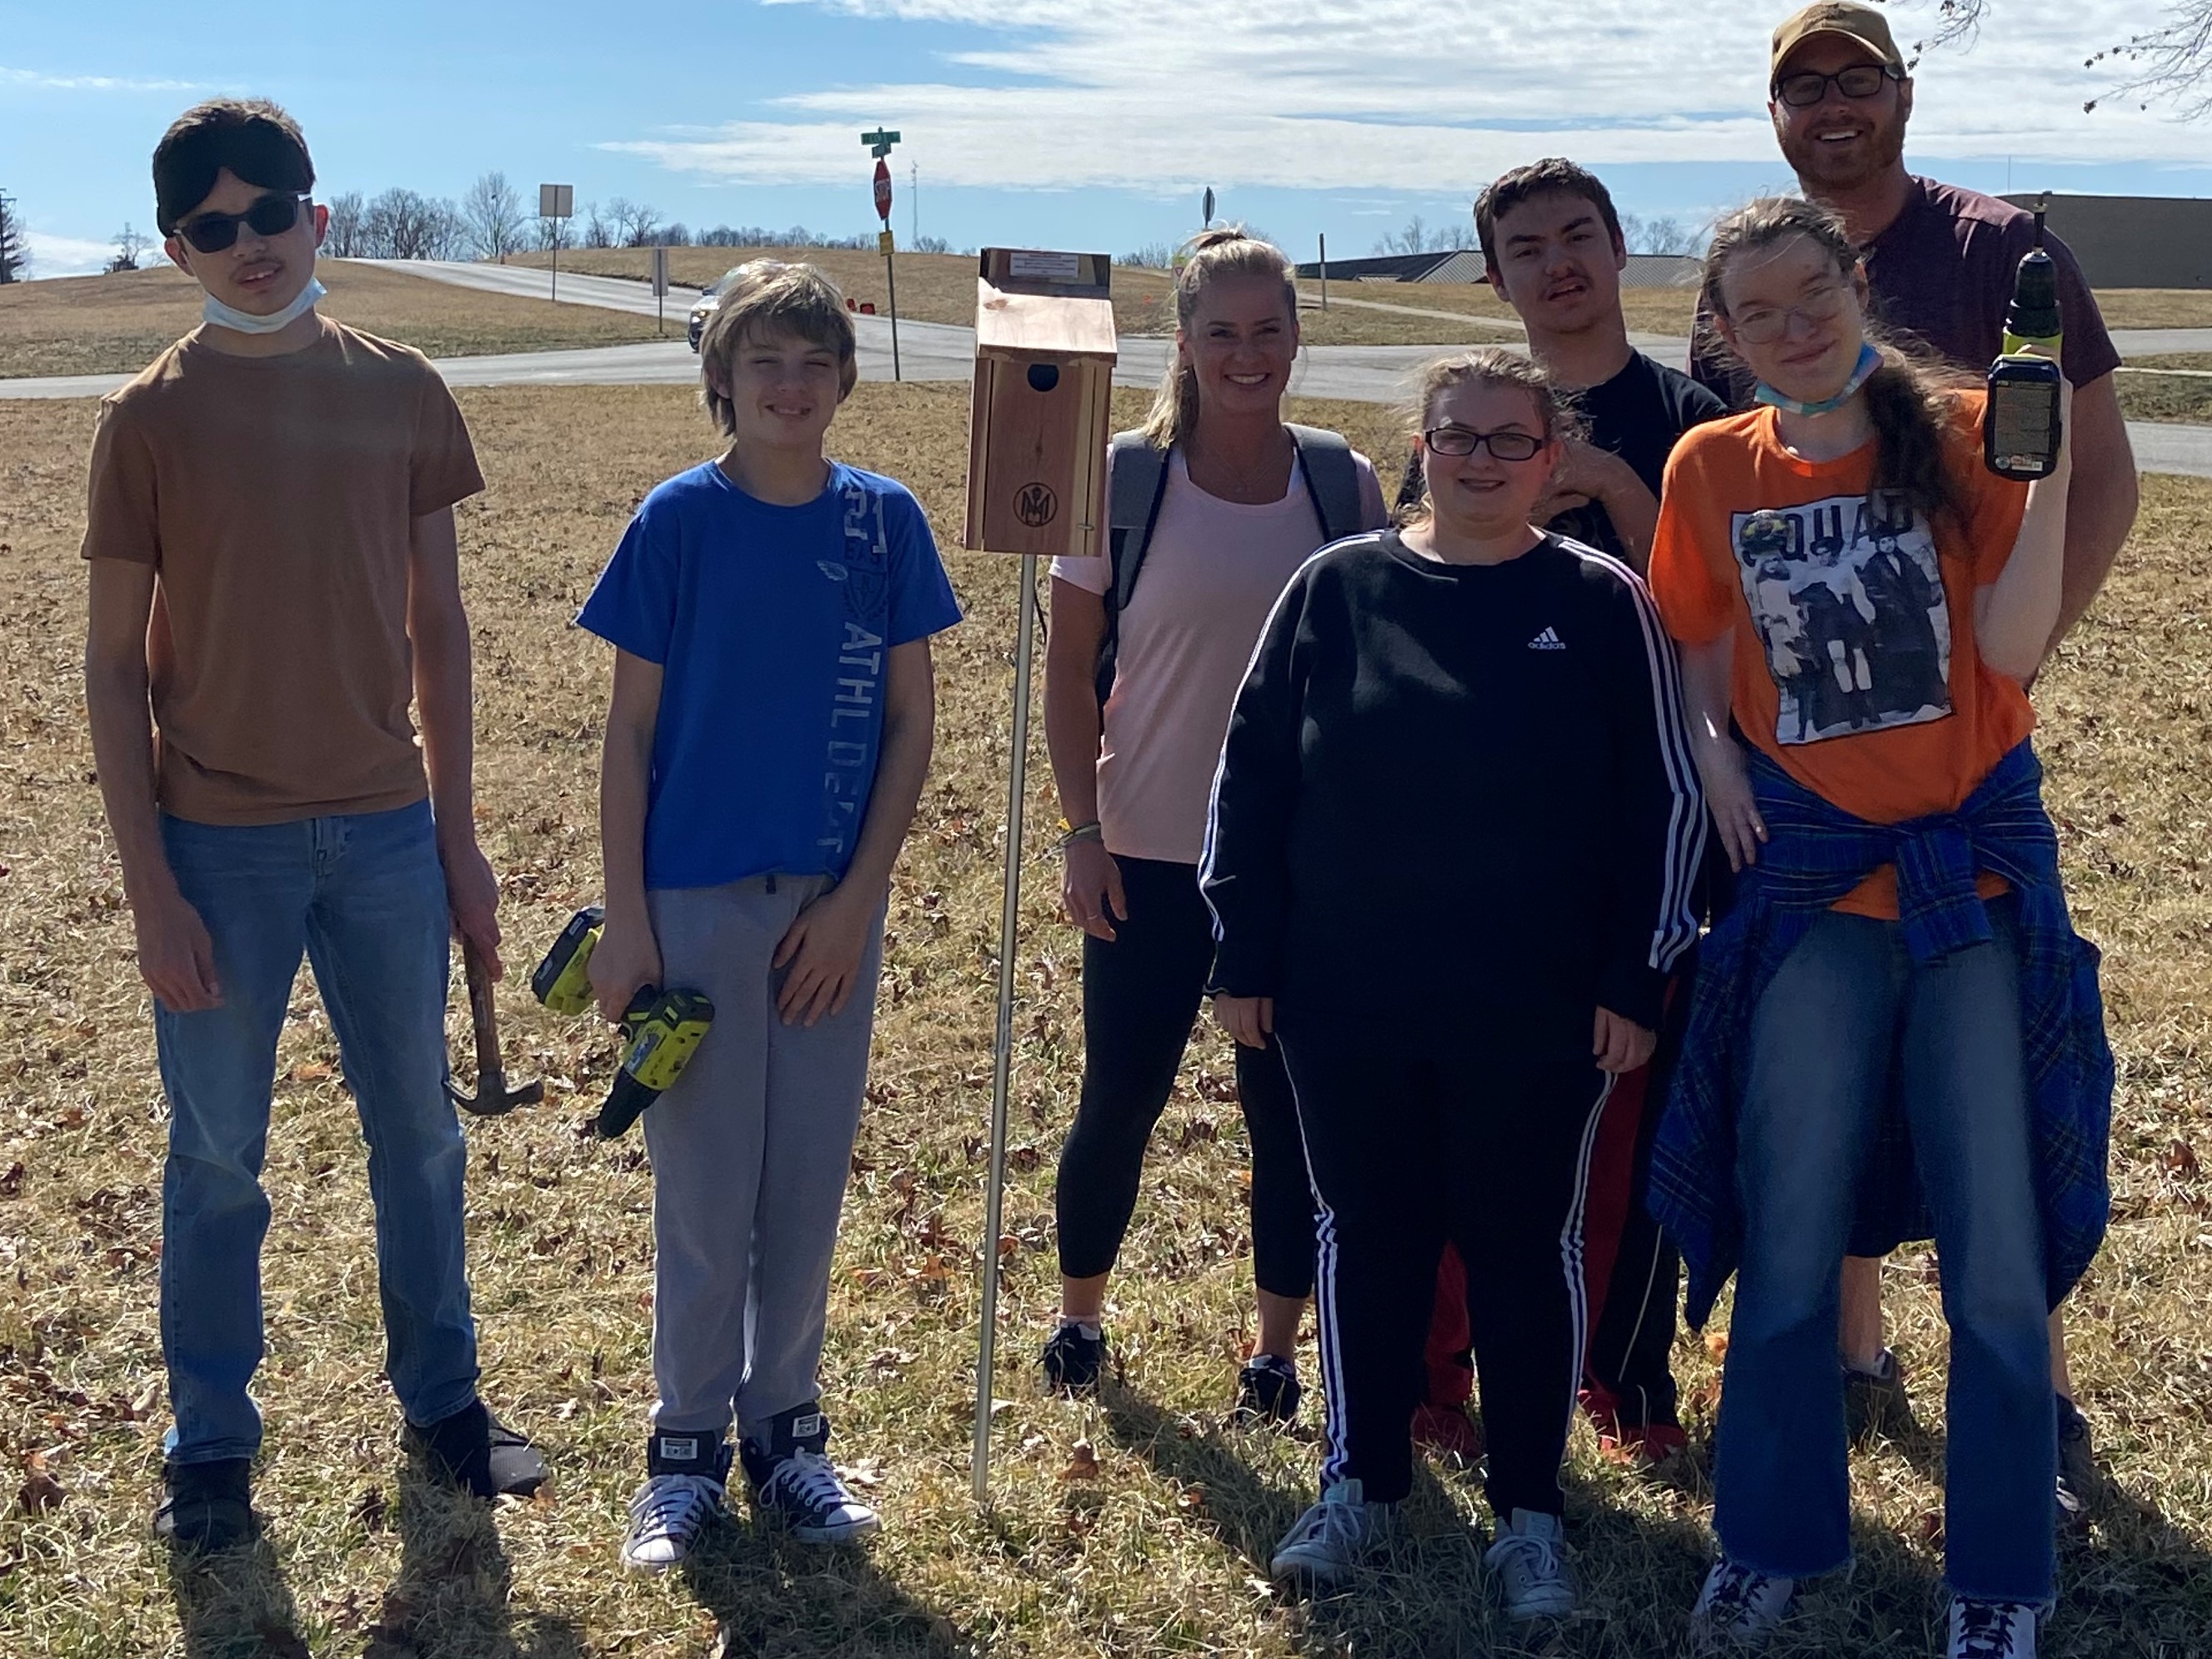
top-left (1201, 352), bottom-right (1705, 1617)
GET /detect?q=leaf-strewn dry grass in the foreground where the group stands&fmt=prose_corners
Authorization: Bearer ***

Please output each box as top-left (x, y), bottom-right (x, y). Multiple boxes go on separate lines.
top-left (0, 385), bottom-right (2212, 1659)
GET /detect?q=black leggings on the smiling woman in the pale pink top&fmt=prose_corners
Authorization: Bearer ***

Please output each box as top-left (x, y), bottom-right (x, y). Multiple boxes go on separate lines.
top-left (1053, 856), bottom-right (1314, 1296)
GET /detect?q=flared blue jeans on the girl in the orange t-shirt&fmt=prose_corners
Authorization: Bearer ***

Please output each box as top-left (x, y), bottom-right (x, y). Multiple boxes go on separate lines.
top-left (1714, 900), bottom-right (2057, 1604)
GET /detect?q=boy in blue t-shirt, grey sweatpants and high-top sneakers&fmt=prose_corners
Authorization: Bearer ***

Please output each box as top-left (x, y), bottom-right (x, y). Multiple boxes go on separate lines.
top-left (578, 261), bottom-right (960, 1571)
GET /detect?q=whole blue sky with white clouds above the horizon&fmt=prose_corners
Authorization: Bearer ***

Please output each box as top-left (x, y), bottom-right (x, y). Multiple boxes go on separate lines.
top-left (0, 0), bottom-right (2212, 277)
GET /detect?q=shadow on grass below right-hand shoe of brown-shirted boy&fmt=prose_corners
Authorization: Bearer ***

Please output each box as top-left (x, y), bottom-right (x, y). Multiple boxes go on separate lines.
top-left (371, 1458), bottom-right (588, 1659)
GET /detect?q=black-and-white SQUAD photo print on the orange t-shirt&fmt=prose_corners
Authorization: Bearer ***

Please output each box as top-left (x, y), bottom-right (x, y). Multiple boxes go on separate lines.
top-left (1729, 494), bottom-right (1951, 744)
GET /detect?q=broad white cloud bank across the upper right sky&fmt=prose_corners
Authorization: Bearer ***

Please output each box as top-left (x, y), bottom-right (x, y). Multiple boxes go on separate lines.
top-left (604, 0), bottom-right (2203, 193)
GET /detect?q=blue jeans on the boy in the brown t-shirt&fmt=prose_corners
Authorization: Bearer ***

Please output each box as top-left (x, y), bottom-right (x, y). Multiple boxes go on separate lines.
top-left (155, 803), bottom-right (476, 1462)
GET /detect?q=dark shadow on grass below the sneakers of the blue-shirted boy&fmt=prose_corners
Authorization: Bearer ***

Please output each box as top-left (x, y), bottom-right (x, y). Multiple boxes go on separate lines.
top-left (681, 1513), bottom-right (978, 1659)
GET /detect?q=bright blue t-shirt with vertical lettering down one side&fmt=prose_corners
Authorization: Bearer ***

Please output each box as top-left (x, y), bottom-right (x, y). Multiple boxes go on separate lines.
top-left (578, 463), bottom-right (960, 890)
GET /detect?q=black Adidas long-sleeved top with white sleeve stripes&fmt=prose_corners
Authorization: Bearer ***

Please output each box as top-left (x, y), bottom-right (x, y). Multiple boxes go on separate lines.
top-left (1201, 531), bottom-right (1705, 1030)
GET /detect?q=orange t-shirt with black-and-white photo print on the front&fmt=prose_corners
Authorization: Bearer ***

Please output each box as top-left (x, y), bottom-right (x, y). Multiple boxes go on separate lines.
top-left (1650, 392), bottom-right (2035, 918)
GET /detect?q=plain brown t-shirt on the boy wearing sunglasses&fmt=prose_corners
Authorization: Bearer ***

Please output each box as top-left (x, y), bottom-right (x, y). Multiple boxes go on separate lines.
top-left (84, 318), bottom-right (484, 823)
